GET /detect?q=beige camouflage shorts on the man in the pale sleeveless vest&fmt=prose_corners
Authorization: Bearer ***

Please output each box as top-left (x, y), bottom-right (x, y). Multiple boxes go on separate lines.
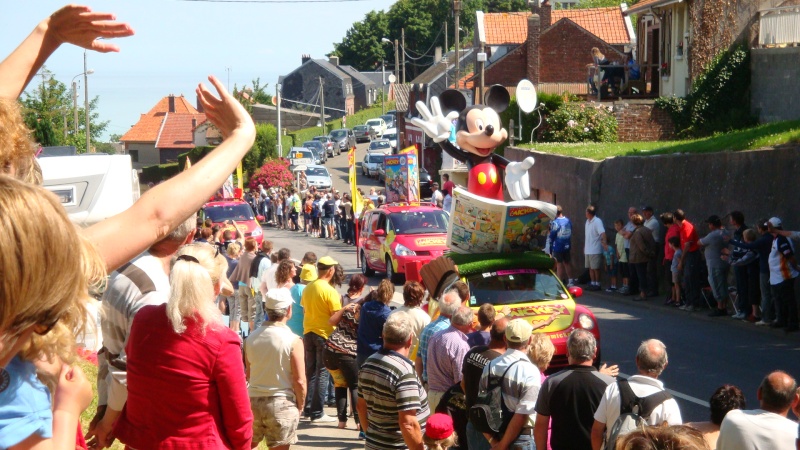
top-left (250, 397), bottom-right (300, 448)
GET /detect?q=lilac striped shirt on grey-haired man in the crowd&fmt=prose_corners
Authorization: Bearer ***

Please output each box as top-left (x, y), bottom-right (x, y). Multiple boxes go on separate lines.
top-left (425, 325), bottom-right (469, 392)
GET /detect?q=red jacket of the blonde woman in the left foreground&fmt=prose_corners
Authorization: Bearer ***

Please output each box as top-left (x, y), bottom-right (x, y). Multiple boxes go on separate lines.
top-left (114, 305), bottom-right (253, 450)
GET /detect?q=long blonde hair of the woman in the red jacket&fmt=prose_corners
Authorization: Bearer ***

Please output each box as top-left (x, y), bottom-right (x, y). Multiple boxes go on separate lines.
top-left (167, 242), bottom-right (228, 334)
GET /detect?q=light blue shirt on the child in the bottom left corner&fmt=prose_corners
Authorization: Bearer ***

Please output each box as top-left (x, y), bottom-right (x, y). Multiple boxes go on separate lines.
top-left (0, 356), bottom-right (53, 448)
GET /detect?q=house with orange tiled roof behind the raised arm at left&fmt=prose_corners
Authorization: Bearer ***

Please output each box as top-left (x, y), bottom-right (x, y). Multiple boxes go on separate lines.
top-left (120, 95), bottom-right (206, 169)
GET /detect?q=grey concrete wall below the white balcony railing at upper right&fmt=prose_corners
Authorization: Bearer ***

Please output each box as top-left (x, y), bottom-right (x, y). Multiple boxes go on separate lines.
top-left (750, 47), bottom-right (800, 122)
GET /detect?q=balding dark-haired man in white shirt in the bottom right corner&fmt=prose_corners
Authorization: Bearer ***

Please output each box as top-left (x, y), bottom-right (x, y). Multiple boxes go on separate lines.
top-left (717, 370), bottom-right (800, 450)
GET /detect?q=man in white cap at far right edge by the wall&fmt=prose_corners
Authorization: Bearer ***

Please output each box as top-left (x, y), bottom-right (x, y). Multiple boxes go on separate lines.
top-left (767, 217), bottom-right (800, 332)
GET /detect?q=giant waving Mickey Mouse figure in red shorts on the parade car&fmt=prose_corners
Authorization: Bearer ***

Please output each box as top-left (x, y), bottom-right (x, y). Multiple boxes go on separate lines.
top-left (411, 85), bottom-right (534, 201)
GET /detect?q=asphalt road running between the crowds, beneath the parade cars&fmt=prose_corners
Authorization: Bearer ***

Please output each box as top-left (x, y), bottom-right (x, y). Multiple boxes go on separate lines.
top-left (265, 139), bottom-right (800, 448)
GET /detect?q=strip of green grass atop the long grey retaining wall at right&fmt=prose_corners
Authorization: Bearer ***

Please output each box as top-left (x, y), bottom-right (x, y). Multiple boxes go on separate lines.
top-left (520, 120), bottom-right (800, 161)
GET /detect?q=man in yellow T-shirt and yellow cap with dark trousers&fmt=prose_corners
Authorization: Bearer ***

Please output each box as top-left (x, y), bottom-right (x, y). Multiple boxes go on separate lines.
top-left (300, 256), bottom-right (342, 423)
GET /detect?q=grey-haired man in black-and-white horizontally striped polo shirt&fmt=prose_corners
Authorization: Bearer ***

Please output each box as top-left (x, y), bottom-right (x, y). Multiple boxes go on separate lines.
top-left (357, 311), bottom-right (430, 450)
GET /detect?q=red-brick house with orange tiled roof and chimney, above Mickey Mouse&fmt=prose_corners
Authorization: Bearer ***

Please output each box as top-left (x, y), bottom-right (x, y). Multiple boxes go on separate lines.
top-left (476, 2), bottom-right (636, 94)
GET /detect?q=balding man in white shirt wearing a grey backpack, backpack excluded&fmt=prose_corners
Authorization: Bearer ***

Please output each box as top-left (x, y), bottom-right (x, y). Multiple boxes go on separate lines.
top-left (592, 339), bottom-right (682, 450)
